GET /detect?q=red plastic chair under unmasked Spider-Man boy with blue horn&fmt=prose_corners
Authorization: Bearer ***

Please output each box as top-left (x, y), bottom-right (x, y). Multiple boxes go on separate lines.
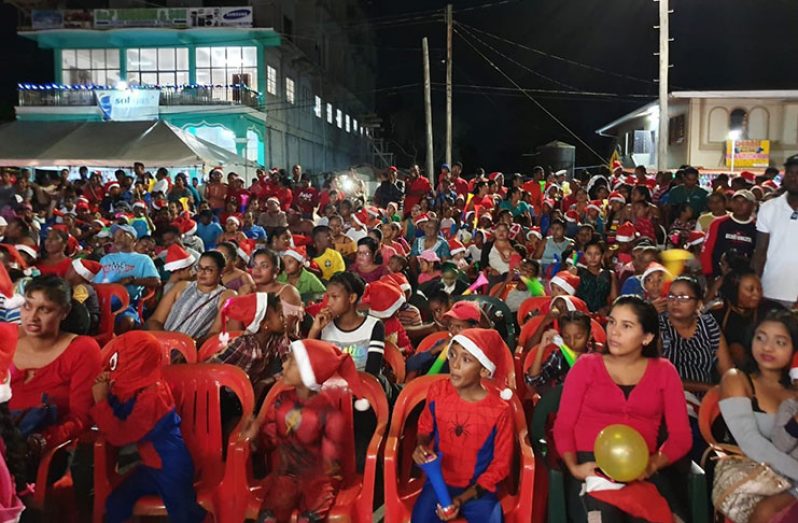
top-left (383, 375), bottom-right (535, 523)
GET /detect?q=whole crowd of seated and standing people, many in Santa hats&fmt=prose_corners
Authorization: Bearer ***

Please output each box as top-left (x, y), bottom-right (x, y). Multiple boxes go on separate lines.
top-left (0, 155), bottom-right (798, 523)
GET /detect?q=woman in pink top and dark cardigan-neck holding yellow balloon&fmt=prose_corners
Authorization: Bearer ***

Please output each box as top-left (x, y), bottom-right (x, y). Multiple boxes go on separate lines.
top-left (554, 296), bottom-right (692, 522)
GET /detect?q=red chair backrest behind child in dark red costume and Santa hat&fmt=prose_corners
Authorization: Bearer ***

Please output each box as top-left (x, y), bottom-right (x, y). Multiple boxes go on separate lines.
top-left (257, 372), bottom-right (389, 487)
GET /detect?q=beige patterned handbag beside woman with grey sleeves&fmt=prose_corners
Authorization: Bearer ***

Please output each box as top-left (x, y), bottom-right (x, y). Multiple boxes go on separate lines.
top-left (712, 455), bottom-right (792, 523)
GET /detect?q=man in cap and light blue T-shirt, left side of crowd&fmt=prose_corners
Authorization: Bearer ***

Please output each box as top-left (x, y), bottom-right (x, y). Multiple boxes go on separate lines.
top-left (94, 225), bottom-right (161, 334)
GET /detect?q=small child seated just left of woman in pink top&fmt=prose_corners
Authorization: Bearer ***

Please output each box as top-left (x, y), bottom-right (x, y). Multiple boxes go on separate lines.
top-left (524, 311), bottom-right (592, 395)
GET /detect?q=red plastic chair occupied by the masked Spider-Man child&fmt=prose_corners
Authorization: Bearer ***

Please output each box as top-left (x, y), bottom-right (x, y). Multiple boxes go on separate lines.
top-left (94, 364), bottom-right (255, 523)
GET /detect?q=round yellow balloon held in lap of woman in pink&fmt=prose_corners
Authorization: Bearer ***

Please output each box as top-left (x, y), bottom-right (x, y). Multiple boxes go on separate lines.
top-left (593, 424), bottom-right (648, 483)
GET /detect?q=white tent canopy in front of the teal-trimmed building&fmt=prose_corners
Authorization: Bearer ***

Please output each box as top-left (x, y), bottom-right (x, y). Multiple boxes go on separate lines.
top-left (0, 120), bottom-right (259, 171)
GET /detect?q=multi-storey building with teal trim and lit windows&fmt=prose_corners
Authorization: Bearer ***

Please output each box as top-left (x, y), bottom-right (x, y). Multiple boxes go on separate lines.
top-left (7, 0), bottom-right (390, 177)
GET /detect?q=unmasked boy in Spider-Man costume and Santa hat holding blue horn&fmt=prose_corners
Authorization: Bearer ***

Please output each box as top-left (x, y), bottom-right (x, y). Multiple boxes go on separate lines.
top-left (412, 329), bottom-right (513, 523)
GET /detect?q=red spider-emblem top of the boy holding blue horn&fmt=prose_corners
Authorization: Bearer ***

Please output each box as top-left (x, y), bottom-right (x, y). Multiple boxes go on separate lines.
top-left (418, 379), bottom-right (514, 492)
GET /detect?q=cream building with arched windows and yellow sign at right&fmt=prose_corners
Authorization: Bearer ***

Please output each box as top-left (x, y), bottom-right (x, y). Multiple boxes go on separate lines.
top-left (596, 90), bottom-right (798, 171)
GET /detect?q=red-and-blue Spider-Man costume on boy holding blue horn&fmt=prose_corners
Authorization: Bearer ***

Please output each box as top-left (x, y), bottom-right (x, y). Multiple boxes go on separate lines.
top-left (412, 380), bottom-right (513, 523)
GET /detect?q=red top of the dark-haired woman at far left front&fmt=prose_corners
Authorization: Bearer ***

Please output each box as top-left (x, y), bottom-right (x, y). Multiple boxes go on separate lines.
top-left (8, 336), bottom-right (102, 445)
